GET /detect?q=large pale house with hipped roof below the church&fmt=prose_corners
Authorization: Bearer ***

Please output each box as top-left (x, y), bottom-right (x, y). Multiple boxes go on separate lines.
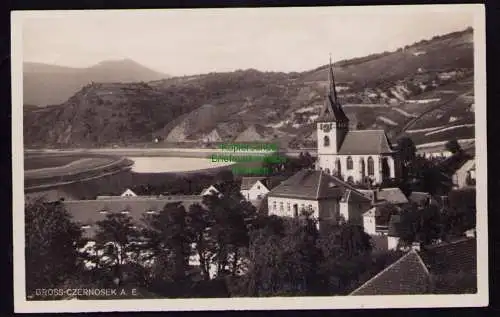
top-left (267, 170), bottom-right (344, 228)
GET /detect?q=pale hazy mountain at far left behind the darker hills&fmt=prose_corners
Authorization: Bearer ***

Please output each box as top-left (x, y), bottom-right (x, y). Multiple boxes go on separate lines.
top-left (23, 59), bottom-right (169, 106)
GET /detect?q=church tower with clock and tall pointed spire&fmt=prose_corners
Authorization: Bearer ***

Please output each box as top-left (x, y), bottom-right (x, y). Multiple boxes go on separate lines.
top-left (317, 58), bottom-right (349, 158)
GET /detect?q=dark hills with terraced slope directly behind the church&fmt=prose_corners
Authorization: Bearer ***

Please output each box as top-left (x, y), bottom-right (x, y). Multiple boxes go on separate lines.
top-left (24, 28), bottom-right (474, 147)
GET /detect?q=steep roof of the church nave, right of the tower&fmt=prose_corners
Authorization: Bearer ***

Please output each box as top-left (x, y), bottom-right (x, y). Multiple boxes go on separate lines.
top-left (338, 130), bottom-right (393, 155)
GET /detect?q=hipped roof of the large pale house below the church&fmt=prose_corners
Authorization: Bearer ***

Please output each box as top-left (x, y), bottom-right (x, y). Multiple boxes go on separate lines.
top-left (268, 170), bottom-right (343, 200)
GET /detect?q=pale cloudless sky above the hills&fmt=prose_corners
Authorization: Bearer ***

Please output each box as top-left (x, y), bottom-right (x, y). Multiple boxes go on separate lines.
top-left (22, 5), bottom-right (474, 76)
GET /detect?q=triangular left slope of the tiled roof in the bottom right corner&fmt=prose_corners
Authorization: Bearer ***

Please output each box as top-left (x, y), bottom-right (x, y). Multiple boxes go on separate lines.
top-left (349, 250), bottom-right (430, 296)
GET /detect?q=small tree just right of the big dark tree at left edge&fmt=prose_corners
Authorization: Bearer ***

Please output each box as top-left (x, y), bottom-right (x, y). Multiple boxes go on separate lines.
top-left (95, 213), bottom-right (140, 282)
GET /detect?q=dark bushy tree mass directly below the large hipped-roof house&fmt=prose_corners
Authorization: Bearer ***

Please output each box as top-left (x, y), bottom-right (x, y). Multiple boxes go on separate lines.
top-left (245, 215), bottom-right (322, 296)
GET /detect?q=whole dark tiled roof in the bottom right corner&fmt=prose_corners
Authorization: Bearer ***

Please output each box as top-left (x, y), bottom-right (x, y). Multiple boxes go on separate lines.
top-left (349, 238), bottom-right (477, 296)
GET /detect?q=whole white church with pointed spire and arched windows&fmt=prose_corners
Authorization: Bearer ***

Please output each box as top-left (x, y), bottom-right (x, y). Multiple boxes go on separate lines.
top-left (316, 61), bottom-right (399, 184)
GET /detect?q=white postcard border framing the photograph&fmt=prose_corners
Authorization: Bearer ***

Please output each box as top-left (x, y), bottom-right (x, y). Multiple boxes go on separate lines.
top-left (11, 4), bottom-right (489, 313)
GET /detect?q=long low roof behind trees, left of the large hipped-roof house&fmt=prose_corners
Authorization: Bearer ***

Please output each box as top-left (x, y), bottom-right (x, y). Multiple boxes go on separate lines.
top-left (61, 195), bottom-right (203, 237)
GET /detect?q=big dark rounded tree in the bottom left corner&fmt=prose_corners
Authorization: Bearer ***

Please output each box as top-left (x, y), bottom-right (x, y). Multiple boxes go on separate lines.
top-left (25, 199), bottom-right (86, 295)
